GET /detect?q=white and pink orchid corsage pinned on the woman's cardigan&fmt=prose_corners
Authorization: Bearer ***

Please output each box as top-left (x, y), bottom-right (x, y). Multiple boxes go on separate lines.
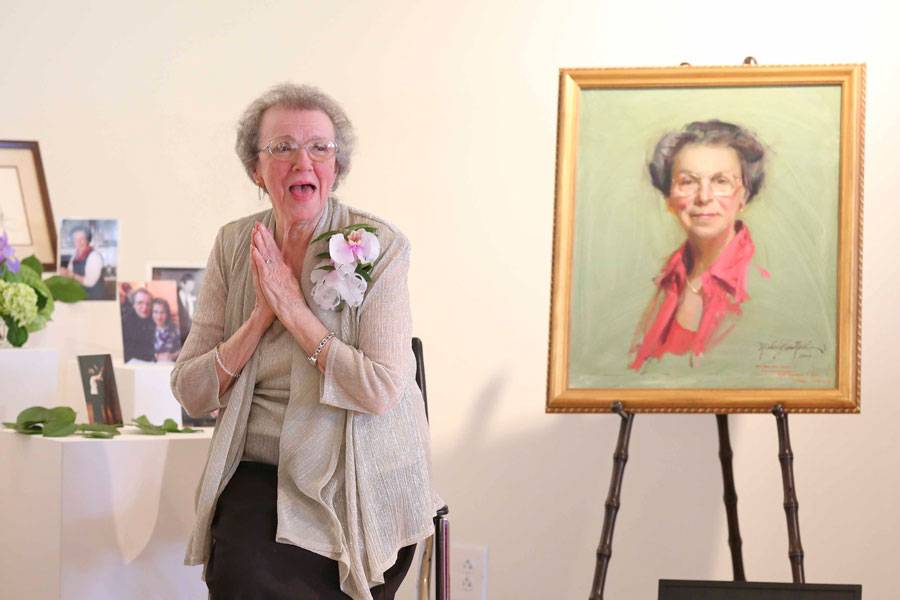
top-left (310, 223), bottom-right (381, 310)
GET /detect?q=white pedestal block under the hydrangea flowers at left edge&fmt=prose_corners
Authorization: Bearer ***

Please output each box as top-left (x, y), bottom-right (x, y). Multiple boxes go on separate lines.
top-left (0, 348), bottom-right (59, 421)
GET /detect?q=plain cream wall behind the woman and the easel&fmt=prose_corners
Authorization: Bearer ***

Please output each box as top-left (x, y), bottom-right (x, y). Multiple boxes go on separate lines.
top-left (0, 0), bottom-right (900, 599)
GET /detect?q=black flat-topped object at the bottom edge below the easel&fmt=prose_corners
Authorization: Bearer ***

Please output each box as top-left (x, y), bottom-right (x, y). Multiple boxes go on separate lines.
top-left (659, 579), bottom-right (862, 600)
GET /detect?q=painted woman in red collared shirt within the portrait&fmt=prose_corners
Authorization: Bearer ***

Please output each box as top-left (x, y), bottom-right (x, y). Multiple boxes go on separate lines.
top-left (630, 120), bottom-right (768, 370)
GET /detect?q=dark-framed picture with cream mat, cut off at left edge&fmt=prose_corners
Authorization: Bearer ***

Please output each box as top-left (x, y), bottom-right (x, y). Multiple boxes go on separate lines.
top-left (0, 140), bottom-right (56, 270)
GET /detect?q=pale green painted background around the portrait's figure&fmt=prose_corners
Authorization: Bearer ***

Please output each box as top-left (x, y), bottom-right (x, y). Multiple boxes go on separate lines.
top-left (569, 85), bottom-right (841, 388)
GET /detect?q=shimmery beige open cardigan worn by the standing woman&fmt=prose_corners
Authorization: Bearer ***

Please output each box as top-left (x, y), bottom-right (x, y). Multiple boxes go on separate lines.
top-left (172, 198), bottom-right (443, 600)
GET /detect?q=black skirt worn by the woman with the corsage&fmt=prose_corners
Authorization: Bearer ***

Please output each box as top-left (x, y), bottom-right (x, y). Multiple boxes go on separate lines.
top-left (206, 461), bottom-right (416, 600)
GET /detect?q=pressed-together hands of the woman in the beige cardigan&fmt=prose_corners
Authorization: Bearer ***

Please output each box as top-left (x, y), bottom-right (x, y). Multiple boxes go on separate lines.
top-left (250, 221), bottom-right (308, 328)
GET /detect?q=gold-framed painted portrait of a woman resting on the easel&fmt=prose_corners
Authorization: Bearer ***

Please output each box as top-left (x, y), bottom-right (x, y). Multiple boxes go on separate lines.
top-left (547, 64), bottom-right (865, 413)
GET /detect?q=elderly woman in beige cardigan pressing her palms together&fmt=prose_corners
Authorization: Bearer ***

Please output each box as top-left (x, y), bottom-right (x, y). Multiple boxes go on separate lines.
top-left (172, 84), bottom-right (442, 599)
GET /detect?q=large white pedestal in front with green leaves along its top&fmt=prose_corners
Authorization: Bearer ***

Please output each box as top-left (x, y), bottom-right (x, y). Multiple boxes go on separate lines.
top-left (0, 428), bottom-right (212, 600)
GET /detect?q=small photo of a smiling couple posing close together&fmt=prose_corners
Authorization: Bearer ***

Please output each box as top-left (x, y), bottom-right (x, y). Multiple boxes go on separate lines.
top-left (119, 281), bottom-right (181, 364)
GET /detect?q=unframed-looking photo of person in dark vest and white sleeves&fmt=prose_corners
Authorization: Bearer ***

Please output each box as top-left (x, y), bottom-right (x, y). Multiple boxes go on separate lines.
top-left (57, 219), bottom-right (119, 300)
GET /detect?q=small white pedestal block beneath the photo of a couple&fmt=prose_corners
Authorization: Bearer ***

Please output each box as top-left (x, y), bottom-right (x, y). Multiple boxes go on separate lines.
top-left (115, 364), bottom-right (181, 425)
